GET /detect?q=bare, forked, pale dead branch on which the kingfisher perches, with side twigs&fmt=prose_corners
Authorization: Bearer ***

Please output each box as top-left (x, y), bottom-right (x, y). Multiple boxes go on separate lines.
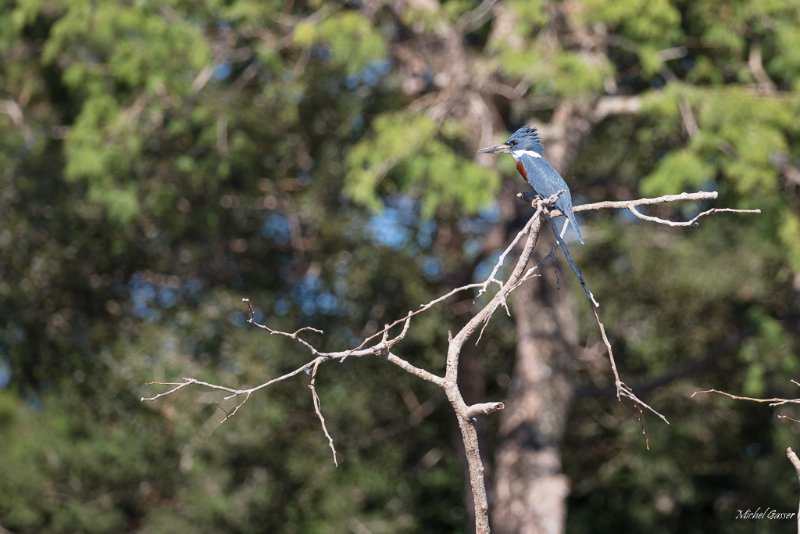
top-left (141, 192), bottom-right (748, 532)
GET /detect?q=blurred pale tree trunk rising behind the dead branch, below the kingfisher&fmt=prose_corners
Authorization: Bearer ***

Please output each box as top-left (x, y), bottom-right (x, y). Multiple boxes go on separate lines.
top-left (493, 279), bottom-right (576, 533)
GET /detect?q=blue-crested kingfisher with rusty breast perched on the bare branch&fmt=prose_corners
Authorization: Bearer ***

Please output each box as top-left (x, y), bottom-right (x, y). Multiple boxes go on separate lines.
top-left (479, 126), bottom-right (583, 244)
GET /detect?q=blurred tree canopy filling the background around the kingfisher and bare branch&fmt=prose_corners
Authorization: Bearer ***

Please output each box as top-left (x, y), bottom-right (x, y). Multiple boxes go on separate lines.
top-left (0, 0), bottom-right (800, 532)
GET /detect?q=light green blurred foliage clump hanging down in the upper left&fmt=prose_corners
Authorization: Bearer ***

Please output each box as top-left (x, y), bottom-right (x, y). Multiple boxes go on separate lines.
top-left (37, 2), bottom-right (210, 224)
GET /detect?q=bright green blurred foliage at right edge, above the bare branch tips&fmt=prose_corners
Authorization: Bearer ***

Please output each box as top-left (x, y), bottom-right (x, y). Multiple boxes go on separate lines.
top-left (640, 88), bottom-right (800, 276)
